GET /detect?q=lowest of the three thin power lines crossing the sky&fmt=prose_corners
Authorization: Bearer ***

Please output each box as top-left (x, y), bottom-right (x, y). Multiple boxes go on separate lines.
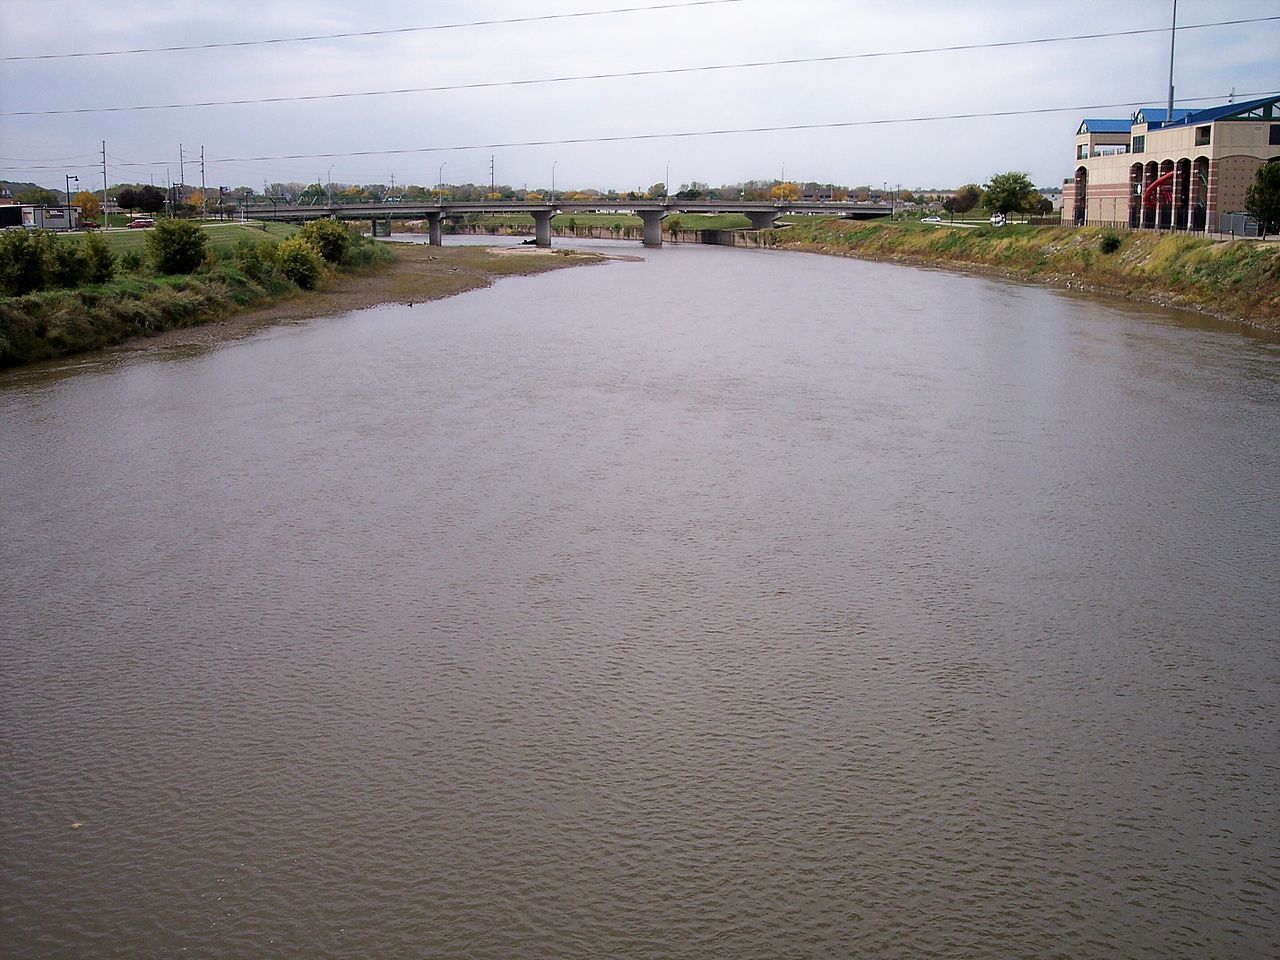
top-left (12, 90), bottom-right (1280, 170)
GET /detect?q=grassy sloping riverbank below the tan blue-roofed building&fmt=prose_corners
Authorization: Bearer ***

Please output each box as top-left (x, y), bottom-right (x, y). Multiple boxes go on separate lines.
top-left (772, 220), bottom-right (1280, 330)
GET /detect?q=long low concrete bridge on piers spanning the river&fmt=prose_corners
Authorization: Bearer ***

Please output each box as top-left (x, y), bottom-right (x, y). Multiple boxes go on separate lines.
top-left (244, 197), bottom-right (893, 247)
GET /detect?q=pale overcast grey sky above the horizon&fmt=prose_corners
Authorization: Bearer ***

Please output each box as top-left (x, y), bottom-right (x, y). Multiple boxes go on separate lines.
top-left (0, 0), bottom-right (1280, 189)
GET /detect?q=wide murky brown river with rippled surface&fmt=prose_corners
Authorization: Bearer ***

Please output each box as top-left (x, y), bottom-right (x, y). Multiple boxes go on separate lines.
top-left (0, 238), bottom-right (1280, 960)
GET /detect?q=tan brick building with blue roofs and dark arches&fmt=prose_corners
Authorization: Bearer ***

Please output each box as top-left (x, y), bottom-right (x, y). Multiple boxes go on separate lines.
top-left (1062, 97), bottom-right (1280, 232)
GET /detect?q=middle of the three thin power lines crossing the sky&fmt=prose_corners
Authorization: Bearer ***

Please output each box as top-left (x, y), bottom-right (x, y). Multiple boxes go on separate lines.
top-left (0, 17), bottom-right (1280, 116)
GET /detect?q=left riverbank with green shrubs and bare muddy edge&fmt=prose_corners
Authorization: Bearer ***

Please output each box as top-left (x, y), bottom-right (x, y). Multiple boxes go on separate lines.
top-left (0, 243), bottom-right (600, 367)
